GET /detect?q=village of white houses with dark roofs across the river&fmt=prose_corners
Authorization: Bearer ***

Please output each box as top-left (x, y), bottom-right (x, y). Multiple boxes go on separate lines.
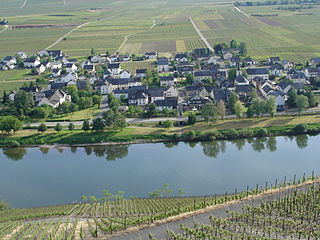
top-left (0, 44), bottom-right (320, 119)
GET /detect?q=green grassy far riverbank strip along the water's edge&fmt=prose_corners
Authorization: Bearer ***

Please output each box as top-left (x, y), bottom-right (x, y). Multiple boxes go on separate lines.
top-left (0, 120), bottom-right (320, 147)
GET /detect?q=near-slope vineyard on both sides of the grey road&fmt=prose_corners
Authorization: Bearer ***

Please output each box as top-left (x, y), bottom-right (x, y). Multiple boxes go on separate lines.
top-left (0, 175), bottom-right (320, 240)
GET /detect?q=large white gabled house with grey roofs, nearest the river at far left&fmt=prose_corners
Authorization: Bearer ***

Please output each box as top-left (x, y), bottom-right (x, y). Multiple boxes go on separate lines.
top-left (38, 89), bottom-right (71, 108)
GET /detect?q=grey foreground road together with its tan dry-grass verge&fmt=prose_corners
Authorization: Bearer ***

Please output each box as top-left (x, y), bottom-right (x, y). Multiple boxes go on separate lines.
top-left (108, 179), bottom-right (319, 240)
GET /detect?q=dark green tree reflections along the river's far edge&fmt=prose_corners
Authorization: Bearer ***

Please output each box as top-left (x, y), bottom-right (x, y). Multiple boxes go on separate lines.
top-left (2, 135), bottom-right (309, 161)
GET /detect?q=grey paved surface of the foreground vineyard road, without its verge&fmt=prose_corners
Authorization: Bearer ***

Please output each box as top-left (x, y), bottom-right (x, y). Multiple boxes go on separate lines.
top-left (110, 182), bottom-right (319, 240)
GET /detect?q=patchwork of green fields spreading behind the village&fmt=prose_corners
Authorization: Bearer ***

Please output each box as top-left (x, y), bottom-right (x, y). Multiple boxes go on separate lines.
top-left (0, 0), bottom-right (320, 62)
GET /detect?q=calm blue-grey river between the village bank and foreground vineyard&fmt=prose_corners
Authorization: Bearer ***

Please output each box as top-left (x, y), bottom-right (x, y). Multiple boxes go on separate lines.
top-left (0, 135), bottom-right (320, 207)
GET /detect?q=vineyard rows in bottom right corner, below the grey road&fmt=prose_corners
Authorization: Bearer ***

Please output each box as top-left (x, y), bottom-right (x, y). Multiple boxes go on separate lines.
top-left (167, 182), bottom-right (320, 240)
